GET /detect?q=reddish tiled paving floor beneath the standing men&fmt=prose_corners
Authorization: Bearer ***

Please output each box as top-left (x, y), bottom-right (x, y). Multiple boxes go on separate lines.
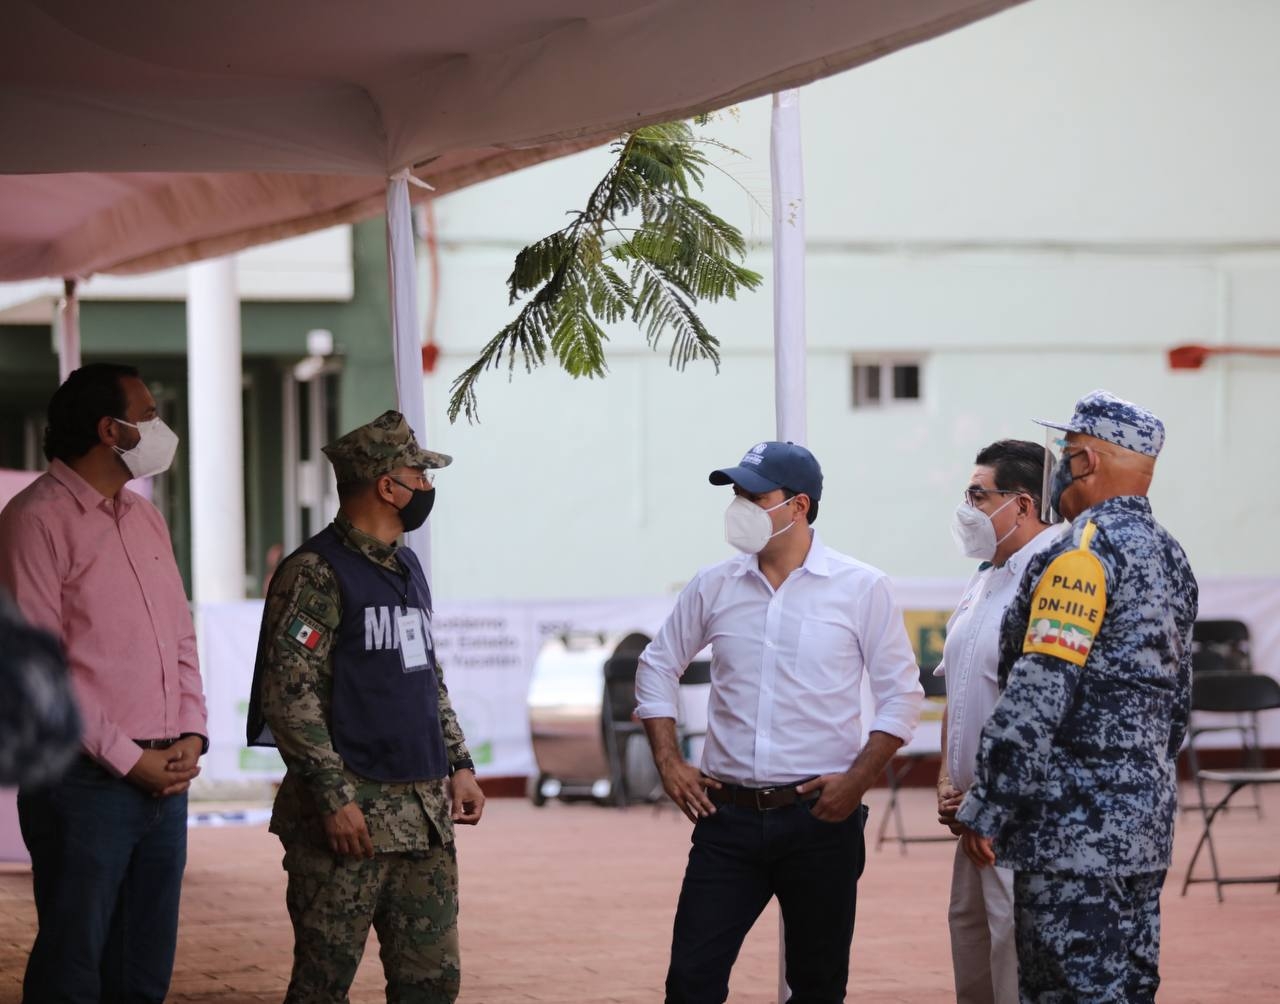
top-left (0, 790), bottom-right (1280, 1004)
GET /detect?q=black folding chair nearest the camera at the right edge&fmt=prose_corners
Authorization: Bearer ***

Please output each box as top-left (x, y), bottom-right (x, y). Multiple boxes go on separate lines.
top-left (1183, 671), bottom-right (1280, 903)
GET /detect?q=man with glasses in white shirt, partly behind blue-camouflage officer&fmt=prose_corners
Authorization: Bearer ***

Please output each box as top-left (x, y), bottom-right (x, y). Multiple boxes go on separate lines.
top-left (936, 439), bottom-right (1062, 1004)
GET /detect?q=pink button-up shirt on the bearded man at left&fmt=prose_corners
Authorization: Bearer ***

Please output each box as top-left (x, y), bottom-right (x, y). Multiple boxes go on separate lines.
top-left (0, 460), bottom-right (209, 775)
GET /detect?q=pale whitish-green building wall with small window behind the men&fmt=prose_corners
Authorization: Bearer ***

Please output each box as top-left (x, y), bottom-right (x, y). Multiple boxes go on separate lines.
top-left (426, 0), bottom-right (1280, 599)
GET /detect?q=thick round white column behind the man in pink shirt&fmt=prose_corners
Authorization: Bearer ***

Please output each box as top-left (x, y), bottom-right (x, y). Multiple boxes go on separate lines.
top-left (186, 257), bottom-right (244, 607)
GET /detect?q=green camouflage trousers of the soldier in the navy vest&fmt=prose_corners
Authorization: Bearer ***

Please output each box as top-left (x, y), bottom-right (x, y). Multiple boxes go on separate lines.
top-left (284, 844), bottom-right (461, 1004)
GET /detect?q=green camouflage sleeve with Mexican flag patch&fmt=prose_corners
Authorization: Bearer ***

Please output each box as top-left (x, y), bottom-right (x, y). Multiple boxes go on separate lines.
top-left (262, 553), bottom-right (356, 812)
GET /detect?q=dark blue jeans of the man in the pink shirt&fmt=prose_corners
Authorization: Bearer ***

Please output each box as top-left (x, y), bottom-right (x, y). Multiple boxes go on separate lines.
top-left (18, 757), bottom-right (187, 1004)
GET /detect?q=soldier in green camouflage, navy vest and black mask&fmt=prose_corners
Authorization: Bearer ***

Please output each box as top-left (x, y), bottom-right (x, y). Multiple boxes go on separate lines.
top-left (241, 411), bottom-right (484, 1004)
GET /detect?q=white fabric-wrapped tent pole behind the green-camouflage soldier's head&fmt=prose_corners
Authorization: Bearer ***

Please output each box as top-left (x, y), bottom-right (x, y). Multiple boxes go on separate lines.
top-left (387, 178), bottom-right (431, 574)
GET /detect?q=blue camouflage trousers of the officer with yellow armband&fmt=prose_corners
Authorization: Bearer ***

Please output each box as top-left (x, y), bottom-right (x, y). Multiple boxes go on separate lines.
top-left (1014, 871), bottom-right (1165, 1004)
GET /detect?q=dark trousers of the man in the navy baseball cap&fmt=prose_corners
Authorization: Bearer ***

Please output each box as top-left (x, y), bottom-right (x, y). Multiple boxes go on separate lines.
top-left (667, 803), bottom-right (867, 1004)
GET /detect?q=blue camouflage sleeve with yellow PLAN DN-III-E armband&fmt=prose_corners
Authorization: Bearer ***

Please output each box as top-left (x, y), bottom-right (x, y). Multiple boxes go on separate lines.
top-left (956, 532), bottom-right (1111, 838)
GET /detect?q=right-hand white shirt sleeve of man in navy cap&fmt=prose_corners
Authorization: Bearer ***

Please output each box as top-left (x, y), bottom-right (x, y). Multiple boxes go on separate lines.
top-left (863, 579), bottom-right (924, 743)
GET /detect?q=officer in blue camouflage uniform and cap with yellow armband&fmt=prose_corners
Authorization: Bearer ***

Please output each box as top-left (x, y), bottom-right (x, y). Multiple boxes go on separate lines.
top-left (957, 391), bottom-right (1198, 1004)
